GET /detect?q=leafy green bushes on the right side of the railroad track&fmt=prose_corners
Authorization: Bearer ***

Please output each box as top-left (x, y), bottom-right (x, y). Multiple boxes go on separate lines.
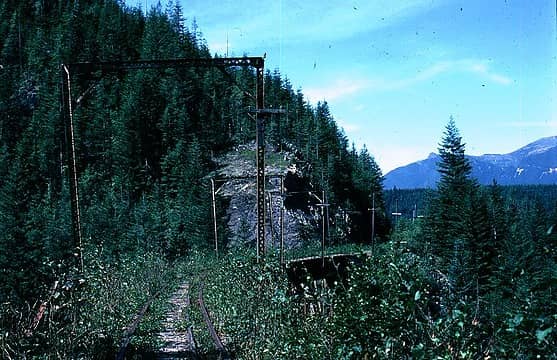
top-left (186, 243), bottom-right (557, 359)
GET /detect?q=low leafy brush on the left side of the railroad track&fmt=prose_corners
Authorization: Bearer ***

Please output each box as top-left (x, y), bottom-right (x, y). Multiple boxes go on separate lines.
top-left (0, 249), bottom-right (176, 359)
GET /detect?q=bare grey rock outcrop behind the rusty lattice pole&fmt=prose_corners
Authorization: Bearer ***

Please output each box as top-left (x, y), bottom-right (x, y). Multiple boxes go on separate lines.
top-left (212, 143), bottom-right (316, 249)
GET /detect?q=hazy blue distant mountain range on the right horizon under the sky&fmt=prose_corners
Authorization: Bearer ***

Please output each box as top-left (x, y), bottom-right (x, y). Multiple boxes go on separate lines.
top-left (384, 136), bottom-right (557, 189)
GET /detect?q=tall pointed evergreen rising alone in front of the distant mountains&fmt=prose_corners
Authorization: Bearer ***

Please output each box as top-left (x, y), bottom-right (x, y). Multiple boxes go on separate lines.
top-left (424, 117), bottom-right (493, 303)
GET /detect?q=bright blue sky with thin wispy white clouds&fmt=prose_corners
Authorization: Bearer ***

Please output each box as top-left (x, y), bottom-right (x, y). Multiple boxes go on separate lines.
top-left (127, 0), bottom-right (557, 173)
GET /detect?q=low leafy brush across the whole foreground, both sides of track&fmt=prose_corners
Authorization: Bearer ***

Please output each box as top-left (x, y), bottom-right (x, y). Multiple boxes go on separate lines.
top-left (0, 242), bottom-right (557, 359)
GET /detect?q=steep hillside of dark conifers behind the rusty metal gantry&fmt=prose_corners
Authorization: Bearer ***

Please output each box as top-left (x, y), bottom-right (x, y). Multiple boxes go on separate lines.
top-left (0, 0), bottom-right (389, 357)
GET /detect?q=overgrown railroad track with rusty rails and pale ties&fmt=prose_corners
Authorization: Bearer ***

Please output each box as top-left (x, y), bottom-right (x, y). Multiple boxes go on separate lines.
top-left (116, 283), bottom-right (231, 360)
